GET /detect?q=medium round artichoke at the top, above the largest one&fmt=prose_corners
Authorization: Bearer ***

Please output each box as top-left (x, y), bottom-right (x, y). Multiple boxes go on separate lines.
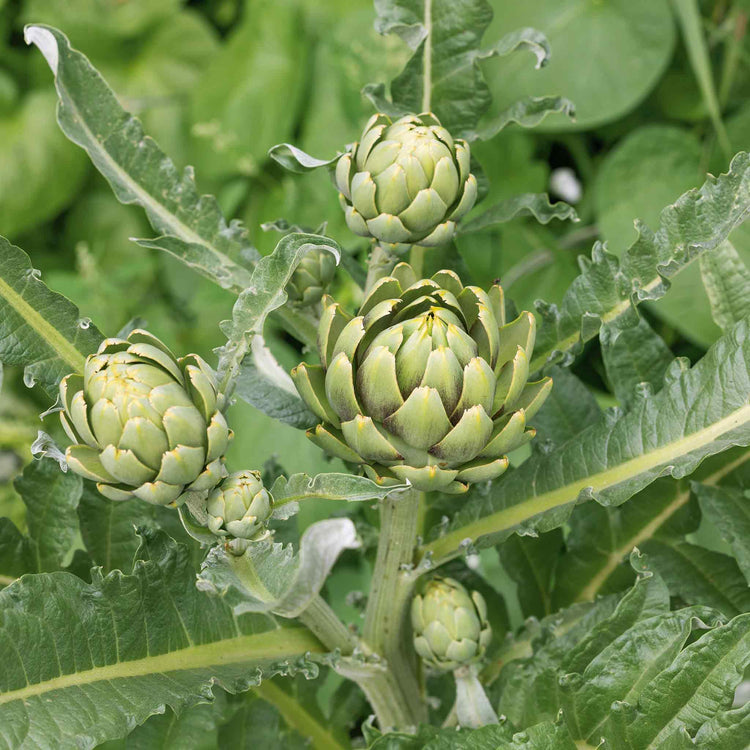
top-left (334, 113), bottom-right (477, 247)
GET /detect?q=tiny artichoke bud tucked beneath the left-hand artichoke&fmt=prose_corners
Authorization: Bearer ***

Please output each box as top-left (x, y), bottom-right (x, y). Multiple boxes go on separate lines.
top-left (206, 471), bottom-right (273, 541)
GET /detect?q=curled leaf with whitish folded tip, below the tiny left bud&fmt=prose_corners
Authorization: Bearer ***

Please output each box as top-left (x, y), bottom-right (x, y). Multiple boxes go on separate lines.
top-left (198, 518), bottom-right (360, 617)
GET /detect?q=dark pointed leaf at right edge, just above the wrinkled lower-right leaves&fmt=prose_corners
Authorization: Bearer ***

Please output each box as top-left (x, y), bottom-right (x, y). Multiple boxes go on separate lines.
top-left (641, 539), bottom-right (750, 617)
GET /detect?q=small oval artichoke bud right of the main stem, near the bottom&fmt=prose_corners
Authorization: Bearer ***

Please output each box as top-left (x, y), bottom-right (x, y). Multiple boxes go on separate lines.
top-left (411, 578), bottom-right (492, 671)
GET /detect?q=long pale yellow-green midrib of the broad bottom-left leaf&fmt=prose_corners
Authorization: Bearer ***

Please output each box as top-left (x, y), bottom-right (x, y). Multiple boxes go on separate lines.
top-left (0, 627), bottom-right (324, 705)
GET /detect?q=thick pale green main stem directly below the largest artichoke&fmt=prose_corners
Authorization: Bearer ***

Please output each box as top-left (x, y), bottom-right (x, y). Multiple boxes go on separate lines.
top-left (362, 490), bottom-right (426, 729)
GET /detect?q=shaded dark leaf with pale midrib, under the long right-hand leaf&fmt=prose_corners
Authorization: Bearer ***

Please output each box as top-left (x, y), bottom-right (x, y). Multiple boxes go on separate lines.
top-left (554, 448), bottom-right (750, 606)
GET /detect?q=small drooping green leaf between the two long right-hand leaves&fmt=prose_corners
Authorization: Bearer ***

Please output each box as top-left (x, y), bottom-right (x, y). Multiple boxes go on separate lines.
top-left (532, 367), bottom-right (602, 448)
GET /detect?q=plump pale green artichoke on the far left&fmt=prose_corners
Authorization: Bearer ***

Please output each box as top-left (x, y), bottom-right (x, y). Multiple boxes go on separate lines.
top-left (60, 330), bottom-right (232, 505)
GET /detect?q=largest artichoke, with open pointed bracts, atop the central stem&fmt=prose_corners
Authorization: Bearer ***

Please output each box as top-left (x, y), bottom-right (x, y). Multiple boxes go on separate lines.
top-left (292, 263), bottom-right (552, 493)
